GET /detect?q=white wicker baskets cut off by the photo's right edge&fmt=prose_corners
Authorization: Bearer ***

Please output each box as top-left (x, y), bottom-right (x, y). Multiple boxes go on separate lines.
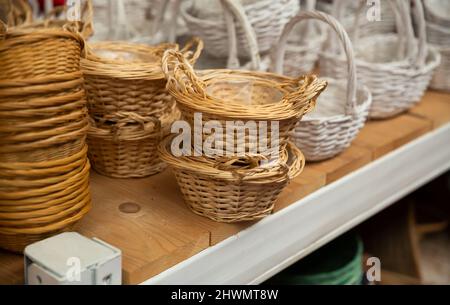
top-left (423, 0), bottom-right (450, 91)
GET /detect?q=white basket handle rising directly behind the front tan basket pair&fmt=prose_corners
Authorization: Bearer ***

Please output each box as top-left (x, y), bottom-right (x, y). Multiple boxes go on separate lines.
top-left (221, 0), bottom-right (261, 70)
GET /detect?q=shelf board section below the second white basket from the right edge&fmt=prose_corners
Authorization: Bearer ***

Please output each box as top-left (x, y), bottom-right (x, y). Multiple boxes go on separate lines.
top-left (353, 114), bottom-right (432, 160)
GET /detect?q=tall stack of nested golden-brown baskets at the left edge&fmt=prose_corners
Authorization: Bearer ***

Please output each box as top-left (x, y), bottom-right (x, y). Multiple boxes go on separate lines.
top-left (0, 26), bottom-right (91, 252)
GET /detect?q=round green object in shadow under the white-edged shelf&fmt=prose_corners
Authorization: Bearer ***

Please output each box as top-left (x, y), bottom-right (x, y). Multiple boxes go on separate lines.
top-left (271, 234), bottom-right (363, 285)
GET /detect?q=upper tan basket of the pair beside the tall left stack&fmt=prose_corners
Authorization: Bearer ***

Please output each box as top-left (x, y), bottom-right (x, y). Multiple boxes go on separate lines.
top-left (81, 40), bottom-right (203, 119)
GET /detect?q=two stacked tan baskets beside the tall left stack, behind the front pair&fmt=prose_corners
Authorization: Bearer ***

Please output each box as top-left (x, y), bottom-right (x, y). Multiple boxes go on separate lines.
top-left (81, 40), bottom-right (202, 178)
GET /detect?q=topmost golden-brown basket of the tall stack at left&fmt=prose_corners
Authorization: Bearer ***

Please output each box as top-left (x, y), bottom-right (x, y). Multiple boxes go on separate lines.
top-left (0, 29), bottom-right (84, 80)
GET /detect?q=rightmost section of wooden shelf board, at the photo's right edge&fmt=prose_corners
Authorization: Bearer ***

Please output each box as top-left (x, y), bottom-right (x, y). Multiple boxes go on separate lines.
top-left (410, 91), bottom-right (450, 128)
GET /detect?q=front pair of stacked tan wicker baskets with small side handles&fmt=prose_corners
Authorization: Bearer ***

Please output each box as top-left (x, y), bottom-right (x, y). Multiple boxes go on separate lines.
top-left (159, 51), bottom-right (326, 222)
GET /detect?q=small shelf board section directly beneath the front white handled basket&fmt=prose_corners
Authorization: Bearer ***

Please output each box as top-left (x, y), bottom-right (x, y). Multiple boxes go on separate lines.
top-left (308, 145), bottom-right (372, 184)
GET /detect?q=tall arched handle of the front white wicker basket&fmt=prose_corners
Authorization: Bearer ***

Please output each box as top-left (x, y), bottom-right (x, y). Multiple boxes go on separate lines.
top-left (274, 11), bottom-right (357, 114)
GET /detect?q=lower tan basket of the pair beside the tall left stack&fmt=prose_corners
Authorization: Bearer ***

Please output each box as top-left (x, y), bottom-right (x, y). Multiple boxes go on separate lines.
top-left (88, 105), bottom-right (180, 178)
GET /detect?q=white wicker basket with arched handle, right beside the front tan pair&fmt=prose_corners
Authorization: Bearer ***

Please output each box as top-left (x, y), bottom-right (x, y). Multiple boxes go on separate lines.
top-left (275, 12), bottom-right (372, 161)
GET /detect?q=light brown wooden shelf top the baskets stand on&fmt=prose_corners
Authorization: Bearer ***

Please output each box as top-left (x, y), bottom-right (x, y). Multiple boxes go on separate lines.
top-left (0, 92), bottom-right (450, 284)
